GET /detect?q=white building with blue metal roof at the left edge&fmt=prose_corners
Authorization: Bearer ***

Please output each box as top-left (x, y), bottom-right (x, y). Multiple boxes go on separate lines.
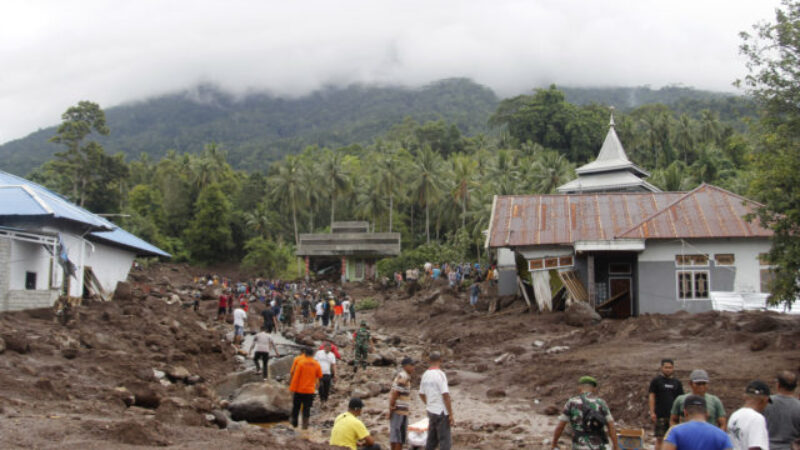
top-left (0, 171), bottom-right (170, 311)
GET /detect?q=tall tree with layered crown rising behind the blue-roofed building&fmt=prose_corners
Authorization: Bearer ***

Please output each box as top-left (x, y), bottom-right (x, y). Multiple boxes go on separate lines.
top-left (50, 100), bottom-right (109, 206)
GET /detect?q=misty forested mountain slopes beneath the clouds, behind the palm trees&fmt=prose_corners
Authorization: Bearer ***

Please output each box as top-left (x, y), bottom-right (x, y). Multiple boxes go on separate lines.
top-left (0, 79), bottom-right (754, 175)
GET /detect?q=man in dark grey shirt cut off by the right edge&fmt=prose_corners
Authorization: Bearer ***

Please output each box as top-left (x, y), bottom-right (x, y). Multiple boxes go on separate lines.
top-left (764, 370), bottom-right (800, 450)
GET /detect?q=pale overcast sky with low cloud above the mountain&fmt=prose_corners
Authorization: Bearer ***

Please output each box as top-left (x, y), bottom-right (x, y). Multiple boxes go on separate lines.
top-left (0, 0), bottom-right (778, 143)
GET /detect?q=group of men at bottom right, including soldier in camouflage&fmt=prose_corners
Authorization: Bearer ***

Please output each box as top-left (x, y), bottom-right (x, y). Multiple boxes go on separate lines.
top-left (553, 359), bottom-right (800, 450)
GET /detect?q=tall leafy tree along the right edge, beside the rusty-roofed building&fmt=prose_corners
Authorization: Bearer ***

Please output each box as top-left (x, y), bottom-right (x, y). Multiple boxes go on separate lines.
top-left (737, 0), bottom-right (800, 305)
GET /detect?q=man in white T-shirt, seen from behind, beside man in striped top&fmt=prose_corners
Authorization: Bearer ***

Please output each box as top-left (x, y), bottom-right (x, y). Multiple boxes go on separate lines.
top-left (419, 352), bottom-right (455, 450)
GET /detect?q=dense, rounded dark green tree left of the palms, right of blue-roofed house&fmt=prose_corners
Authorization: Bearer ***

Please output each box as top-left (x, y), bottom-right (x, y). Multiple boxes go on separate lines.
top-left (186, 184), bottom-right (234, 264)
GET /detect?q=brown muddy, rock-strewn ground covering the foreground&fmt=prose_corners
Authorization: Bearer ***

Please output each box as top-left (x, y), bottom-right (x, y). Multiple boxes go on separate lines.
top-left (0, 265), bottom-right (800, 449)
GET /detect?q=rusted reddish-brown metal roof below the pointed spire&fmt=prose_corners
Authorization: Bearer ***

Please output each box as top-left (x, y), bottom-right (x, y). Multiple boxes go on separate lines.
top-left (489, 184), bottom-right (772, 247)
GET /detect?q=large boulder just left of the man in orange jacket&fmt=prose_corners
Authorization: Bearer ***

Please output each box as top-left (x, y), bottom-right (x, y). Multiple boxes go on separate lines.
top-left (228, 380), bottom-right (292, 423)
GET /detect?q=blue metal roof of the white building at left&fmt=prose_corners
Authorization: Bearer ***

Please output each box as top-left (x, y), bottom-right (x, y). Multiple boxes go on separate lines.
top-left (0, 170), bottom-right (171, 258)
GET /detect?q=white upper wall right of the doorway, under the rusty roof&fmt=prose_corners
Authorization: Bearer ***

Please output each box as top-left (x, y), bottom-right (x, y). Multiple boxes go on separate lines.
top-left (639, 238), bottom-right (771, 292)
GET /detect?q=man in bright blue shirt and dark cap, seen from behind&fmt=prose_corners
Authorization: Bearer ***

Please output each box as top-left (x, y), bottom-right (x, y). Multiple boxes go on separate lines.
top-left (661, 394), bottom-right (733, 450)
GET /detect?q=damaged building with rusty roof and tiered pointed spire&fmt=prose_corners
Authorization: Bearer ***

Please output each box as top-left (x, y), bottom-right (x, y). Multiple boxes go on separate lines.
top-left (486, 116), bottom-right (772, 318)
